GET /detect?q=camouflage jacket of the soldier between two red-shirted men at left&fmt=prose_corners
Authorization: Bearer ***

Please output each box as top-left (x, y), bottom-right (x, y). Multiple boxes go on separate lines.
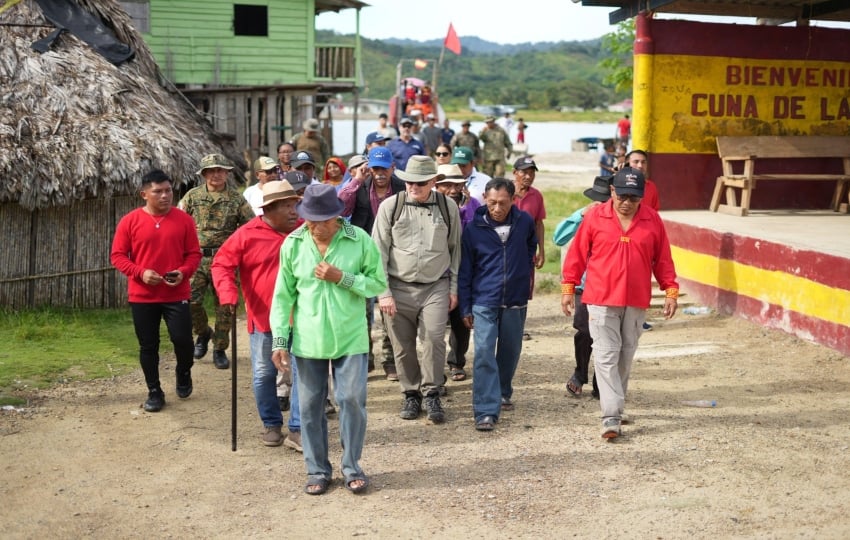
top-left (178, 184), bottom-right (254, 248)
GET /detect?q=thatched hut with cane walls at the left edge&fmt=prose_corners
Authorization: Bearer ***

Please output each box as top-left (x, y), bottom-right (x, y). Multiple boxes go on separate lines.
top-left (0, 0), bottom-right (238, 307)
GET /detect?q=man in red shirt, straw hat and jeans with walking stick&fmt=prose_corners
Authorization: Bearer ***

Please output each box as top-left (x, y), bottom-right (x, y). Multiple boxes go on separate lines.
top-left (211, 179), bottom-right (303, 450)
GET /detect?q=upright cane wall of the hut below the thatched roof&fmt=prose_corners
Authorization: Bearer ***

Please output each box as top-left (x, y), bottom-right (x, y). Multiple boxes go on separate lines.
top-left (0, 197), bottom-right (141, 308)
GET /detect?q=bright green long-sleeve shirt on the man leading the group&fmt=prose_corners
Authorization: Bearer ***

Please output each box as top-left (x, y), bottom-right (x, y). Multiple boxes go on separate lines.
top-left (270, 219), bottom-right (387, 359)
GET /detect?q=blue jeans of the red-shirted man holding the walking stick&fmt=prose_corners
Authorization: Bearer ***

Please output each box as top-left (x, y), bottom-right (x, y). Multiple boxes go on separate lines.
top-left (249, 332), bottom-right (301, 431)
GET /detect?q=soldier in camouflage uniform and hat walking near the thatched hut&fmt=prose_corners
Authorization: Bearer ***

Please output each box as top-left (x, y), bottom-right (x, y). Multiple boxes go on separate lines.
top-left (178, 154), bottom-right (254, 369)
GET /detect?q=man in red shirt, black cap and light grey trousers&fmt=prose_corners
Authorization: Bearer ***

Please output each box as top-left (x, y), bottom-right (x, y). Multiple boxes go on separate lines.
top-left (561, 167), bottom-right (679, 439)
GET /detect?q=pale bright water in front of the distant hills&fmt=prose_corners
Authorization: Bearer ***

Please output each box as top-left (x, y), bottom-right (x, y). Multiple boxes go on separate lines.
top-left (334, 118), bottom-right (617, 155)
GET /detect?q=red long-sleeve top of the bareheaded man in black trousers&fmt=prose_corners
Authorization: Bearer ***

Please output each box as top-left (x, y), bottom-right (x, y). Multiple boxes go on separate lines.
top-left (109, 207), bottom-right (201, 304)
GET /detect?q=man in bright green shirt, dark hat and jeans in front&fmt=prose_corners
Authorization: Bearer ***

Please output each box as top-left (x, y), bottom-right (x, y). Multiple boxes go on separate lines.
top-left (270, 184), bottom-right (387, 495)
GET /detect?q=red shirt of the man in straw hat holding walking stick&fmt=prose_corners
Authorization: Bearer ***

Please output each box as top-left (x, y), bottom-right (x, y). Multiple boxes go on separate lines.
top-left (211, 216), bottom-right (303, 333)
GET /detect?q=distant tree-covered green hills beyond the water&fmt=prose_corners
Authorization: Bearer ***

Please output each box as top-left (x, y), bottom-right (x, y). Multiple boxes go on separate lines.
top-left (316, 30), bottom-right (630, 110)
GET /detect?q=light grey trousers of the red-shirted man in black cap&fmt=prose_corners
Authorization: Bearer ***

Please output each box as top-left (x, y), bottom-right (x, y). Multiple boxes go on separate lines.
top-left (587, 304), bottom-right (646, 422)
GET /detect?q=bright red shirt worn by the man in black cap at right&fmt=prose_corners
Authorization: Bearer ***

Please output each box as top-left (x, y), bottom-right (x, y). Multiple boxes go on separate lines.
top-left (561, 201), bottom-right (679, 309)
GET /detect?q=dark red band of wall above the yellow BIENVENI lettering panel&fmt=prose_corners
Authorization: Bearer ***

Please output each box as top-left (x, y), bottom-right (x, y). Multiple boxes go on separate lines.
top-left (649, 19), bottom-right (850, 61)
